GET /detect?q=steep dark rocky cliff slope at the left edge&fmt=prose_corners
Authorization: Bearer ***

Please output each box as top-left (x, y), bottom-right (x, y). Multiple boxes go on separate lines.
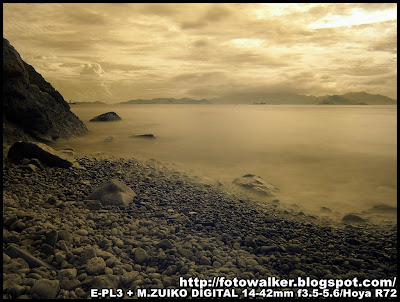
top-left (3, 38), bottom-right (89, 144)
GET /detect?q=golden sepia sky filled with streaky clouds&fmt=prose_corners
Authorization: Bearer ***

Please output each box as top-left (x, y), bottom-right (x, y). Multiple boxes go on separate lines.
top-left (3, 3), bottom-right (397, 103)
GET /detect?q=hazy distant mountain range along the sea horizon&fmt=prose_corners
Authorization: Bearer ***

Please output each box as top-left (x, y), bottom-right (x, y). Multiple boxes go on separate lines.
top-left (119, 92), bottom-right (397, 105)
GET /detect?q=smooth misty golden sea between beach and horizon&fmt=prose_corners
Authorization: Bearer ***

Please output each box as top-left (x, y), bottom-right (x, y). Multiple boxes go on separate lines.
top-left (54, 105), bottom-right (397, 212)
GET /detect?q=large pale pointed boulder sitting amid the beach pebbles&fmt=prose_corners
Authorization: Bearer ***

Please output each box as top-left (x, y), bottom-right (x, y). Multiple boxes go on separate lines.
top-left (86, 179), bottom-right (136, 206)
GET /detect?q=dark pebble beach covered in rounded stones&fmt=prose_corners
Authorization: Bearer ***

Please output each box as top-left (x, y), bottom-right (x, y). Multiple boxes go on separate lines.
top-left (3, 156), bottom-right (397, 298)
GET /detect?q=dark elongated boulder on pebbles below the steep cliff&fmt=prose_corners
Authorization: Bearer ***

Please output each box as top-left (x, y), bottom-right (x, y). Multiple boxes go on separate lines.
top-left (7, 141), bottom-right (77, 168)
